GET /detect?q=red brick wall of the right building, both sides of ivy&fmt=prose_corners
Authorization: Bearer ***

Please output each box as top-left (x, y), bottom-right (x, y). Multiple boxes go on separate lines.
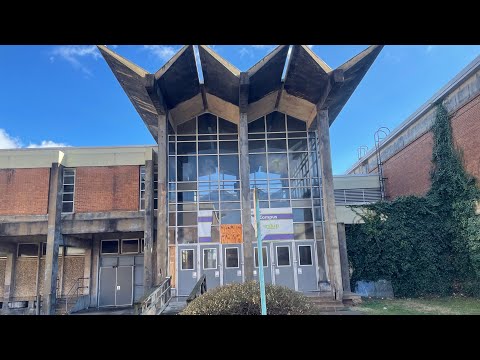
top-left (375, 96), bottom-right (480, 199)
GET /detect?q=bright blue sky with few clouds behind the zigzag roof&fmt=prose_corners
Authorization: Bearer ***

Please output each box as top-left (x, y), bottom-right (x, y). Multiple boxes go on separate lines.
top-left (0, 45), bottom-right (480, 174)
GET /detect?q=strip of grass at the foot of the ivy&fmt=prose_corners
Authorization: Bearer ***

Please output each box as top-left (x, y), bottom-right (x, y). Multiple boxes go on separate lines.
top-left (351, 297), bottom-right (480, 315)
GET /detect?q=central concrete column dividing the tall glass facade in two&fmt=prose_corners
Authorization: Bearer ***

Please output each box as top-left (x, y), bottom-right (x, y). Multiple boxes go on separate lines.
top-left (238, 72), bottom-right (255, 281)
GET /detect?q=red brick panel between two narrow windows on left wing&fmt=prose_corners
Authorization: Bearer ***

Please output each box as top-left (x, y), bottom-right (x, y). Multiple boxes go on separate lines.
top-left (75, 166), bottom-right (140, 212)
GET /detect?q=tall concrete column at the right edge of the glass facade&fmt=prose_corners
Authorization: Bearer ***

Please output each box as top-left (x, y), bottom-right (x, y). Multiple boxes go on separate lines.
top-left (317, 107), bottom-right (343, 300)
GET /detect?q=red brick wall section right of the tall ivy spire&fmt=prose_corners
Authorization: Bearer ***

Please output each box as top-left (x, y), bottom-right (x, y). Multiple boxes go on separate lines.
top-left (452, 96), bottom-right (480, 182)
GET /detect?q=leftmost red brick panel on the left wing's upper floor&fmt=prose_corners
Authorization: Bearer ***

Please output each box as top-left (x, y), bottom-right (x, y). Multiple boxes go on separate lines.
top-left (0, 168), bottom-right (50, 215)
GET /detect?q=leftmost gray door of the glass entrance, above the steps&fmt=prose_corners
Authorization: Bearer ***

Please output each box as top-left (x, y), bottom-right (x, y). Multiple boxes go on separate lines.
top-left (177, 245), bottom-right (197, 296)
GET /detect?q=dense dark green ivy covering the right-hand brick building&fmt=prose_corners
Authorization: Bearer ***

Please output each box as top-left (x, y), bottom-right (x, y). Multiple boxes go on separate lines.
top-left (347, 104), bottom-right (480, 297)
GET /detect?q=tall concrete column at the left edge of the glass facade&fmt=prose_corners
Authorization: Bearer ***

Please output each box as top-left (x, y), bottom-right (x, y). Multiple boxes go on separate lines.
top-left (156, 114), bottom-right (168, 285)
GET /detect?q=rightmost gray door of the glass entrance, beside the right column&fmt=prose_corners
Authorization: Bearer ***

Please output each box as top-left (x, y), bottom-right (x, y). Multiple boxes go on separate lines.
top-left (295, 241), bottom-right (318, 292)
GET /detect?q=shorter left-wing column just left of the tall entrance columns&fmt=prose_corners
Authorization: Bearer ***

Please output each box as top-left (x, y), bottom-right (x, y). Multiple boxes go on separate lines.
top-left (143, 160), bottom-right (155, 293)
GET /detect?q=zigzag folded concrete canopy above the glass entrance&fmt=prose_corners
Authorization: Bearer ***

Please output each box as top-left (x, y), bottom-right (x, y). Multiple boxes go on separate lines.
top-left (98, 45), bottom-right (383, 139)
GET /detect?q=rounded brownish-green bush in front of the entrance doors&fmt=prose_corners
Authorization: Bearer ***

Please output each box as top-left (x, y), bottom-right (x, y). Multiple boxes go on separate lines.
top-left (181, 281), bottom-right (312, 315)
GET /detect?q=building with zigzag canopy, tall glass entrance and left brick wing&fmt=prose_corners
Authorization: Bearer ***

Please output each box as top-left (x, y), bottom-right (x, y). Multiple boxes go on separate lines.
top-left (0, 45), bottom-right (382, 314)
